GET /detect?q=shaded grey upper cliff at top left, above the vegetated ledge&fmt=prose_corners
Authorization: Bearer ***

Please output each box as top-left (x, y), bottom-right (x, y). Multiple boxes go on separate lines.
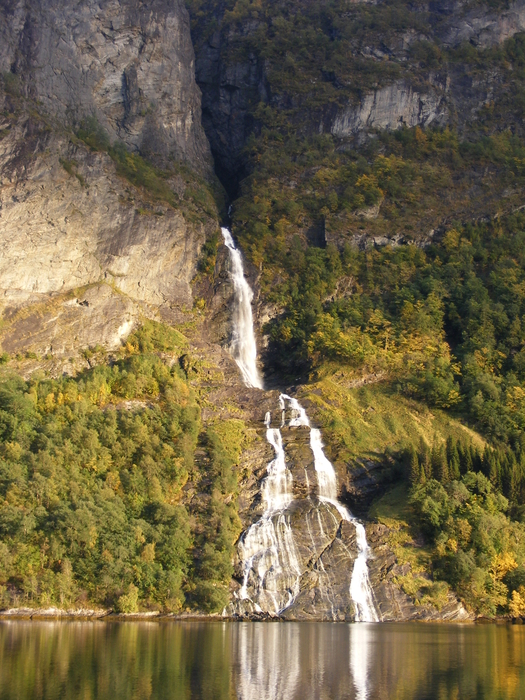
top-left (0, 0), bottom-right (210, 170)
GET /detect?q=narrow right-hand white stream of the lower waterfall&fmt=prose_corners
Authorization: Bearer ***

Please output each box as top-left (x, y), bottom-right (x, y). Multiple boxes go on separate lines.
top-left (282, 394), bottom-right (378, 622)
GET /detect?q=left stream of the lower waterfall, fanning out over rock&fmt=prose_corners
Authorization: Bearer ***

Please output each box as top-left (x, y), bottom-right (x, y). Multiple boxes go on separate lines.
top-left (235, 413), bottom-right (301, 613)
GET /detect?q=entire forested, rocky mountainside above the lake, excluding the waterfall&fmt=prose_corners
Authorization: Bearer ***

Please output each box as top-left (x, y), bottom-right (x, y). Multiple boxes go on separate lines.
top-left (0, 0), bottom-right (525, 620)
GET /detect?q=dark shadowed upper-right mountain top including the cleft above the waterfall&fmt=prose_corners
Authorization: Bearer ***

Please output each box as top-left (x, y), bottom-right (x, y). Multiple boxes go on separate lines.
top-left (189, 0), bottom-right (525, 189)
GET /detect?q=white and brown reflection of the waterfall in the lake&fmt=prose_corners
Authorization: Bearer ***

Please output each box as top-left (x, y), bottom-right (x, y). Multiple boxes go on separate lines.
top-left (234, 622), bottom-right (376, 700)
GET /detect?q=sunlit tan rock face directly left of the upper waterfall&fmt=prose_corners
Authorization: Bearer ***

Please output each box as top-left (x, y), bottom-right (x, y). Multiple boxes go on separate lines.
top-left (0, 110), bottom-right (216, 355)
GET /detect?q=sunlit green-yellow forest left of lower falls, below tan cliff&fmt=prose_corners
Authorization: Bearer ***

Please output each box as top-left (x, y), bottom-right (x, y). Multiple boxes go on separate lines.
top-left (0, 322), bottom-right (244, 612)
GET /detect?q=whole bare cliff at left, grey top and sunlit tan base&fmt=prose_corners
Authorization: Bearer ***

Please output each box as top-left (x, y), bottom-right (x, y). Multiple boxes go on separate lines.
top-left (0, 1), bottom-right (217, 356)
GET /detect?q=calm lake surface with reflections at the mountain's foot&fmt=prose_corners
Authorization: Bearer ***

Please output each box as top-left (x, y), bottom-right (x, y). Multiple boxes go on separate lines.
top-left (0, 621), bottom-right (525, 700)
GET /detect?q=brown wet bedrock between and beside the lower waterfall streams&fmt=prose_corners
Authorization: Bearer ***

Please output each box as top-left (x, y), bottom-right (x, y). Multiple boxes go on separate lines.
top-left (229, 422), bottom-right (469, 621)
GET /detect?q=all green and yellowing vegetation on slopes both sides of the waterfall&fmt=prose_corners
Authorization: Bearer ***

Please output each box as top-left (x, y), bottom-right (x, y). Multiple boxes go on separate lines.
top-left (5, 0), bottom-right (525, 615)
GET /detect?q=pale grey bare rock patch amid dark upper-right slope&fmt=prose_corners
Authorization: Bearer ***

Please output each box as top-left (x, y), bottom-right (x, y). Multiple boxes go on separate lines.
top-left (331, 80), bottom-right (446, 138)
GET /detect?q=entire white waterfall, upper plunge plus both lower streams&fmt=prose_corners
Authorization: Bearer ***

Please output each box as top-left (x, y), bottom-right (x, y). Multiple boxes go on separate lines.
top-left (222, 228), bottom-right (379, 622)
